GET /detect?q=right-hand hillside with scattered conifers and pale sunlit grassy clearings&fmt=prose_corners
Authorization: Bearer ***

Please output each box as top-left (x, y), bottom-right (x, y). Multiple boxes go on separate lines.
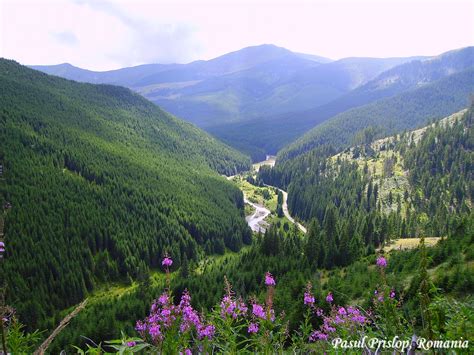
top-left (259, 108), bottom-right (474, 258)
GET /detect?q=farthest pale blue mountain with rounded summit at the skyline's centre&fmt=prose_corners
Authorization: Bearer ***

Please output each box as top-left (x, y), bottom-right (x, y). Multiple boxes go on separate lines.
top-left (33, 45), bottom-right (333, 127)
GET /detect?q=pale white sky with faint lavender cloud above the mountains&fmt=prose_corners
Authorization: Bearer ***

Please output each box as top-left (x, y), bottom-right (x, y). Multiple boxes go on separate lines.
top-left (0, 0), bottom-right (474, 70)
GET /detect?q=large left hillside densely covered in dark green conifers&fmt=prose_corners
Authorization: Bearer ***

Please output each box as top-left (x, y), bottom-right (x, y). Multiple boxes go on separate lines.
top-left (0, 59), bottom-right (251, 328)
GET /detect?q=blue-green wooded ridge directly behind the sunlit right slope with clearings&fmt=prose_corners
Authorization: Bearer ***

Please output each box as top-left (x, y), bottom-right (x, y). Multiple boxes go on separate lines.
top-left (278, 66), bottom-right (474, 161)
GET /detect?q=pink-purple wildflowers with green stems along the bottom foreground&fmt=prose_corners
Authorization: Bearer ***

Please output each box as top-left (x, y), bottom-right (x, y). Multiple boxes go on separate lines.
top-left (111, 257), bottom-right (414, 354)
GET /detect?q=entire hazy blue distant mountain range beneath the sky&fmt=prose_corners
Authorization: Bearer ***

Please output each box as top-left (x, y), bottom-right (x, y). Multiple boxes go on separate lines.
top-left (33, 45), bottom-right (474, 160)
